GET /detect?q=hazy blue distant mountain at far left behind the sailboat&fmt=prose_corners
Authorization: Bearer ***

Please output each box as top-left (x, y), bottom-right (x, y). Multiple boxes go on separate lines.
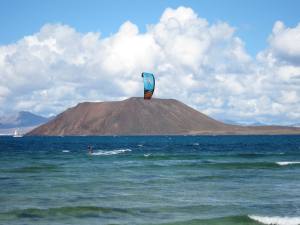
top-left (0, 111), bottom-right (53, 134)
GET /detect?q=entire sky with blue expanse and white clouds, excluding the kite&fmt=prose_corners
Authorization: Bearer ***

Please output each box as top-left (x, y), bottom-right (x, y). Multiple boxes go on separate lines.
top-left (0, 0), bottom-right (300, 125)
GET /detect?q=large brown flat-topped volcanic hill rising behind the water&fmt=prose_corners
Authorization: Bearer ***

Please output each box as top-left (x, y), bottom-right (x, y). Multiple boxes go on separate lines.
top-left (27, 98), bottom-right (300, 136)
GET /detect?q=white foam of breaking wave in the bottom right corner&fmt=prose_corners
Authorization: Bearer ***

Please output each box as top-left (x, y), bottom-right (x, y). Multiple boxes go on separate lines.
top-left (249, 215), bottom-right (300, 225)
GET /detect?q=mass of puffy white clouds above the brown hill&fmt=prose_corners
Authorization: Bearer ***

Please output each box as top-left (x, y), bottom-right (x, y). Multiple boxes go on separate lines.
top-left (0, 7), bottom-right (300, 124)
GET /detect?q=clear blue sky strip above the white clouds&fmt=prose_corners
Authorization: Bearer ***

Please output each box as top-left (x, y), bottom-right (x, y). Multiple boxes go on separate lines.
top-left (0, 0), bottom-right (300, 55)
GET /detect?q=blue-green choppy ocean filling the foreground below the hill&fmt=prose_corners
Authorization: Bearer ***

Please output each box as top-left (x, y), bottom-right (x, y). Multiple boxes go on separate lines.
top-left (0, 135), bottom-right (300, 225)
